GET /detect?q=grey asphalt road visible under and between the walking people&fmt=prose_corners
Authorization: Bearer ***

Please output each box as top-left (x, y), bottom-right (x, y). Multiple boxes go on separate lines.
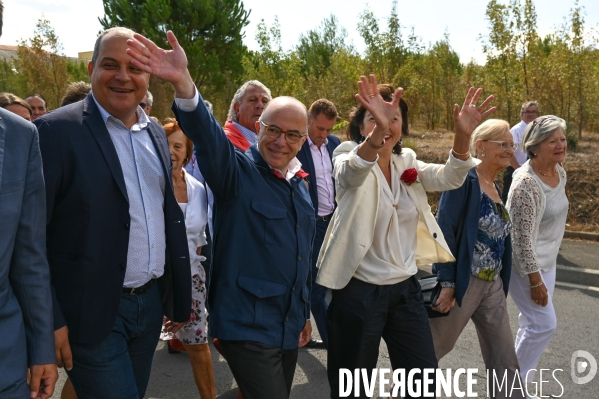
top-left (53, 240), bottom-right (599, 399)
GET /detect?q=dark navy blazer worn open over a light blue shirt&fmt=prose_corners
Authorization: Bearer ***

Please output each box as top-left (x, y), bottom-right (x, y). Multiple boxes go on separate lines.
top-left (35, 93), bottom-right (191, 344)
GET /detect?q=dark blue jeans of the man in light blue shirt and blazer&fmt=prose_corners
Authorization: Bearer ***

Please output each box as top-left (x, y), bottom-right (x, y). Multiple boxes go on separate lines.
top-left (67, 283), bottom-right (164, 399)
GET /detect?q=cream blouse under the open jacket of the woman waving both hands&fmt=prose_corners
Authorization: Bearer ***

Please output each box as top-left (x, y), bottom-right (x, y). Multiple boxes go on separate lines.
top-left (354, 157), bottom-right (420, 285)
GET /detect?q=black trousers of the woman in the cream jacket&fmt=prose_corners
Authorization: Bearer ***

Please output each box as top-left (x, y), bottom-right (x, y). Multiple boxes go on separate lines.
top-left (327, 277), bottom-right (437, 399)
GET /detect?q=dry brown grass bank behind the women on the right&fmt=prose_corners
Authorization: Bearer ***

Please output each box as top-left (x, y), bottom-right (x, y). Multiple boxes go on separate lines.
top-left (410, 123), bottom-right (599, 233)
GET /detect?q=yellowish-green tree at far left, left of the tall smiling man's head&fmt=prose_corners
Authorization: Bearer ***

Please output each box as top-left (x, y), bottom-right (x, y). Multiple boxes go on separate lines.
top-left (15, 17), bottom-right (69, 108)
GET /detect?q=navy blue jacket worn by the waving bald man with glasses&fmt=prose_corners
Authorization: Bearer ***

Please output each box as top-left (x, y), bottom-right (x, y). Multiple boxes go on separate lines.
top-left (173, 97), bottom-right (316, 350)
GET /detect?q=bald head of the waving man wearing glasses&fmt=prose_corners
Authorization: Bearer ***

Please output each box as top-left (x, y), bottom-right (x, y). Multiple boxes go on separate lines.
top-left (256, 97), bottom-right (308, 175)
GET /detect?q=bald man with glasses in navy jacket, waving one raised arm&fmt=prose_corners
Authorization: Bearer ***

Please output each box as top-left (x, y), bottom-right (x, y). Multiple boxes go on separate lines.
top-left (127, 32), bottom-right (315, 399)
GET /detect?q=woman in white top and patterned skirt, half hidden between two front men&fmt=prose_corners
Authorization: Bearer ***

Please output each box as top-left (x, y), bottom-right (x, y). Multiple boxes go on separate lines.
top-left (161, 120), bottom-right (216, 399)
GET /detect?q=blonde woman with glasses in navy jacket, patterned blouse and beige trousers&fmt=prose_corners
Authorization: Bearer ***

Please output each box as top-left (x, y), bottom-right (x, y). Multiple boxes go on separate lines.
top-left (429, 119), bottom-right (523, 398)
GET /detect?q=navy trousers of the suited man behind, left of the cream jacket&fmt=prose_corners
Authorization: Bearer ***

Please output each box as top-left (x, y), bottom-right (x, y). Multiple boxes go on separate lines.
top-left (310, 220), bottom-right (329, 348)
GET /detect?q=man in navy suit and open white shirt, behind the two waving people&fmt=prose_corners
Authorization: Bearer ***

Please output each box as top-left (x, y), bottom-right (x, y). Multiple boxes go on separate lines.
top-left (297, 98), bottom-right (339, 348)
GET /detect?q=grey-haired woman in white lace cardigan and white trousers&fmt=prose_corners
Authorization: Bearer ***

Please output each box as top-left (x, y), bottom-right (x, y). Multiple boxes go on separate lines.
top-left (507, 116), bottom-right (568, 394)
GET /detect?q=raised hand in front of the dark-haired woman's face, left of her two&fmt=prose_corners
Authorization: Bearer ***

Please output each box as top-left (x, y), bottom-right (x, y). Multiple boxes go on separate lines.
top-left (356, 74), bottom-right (403, 130)
